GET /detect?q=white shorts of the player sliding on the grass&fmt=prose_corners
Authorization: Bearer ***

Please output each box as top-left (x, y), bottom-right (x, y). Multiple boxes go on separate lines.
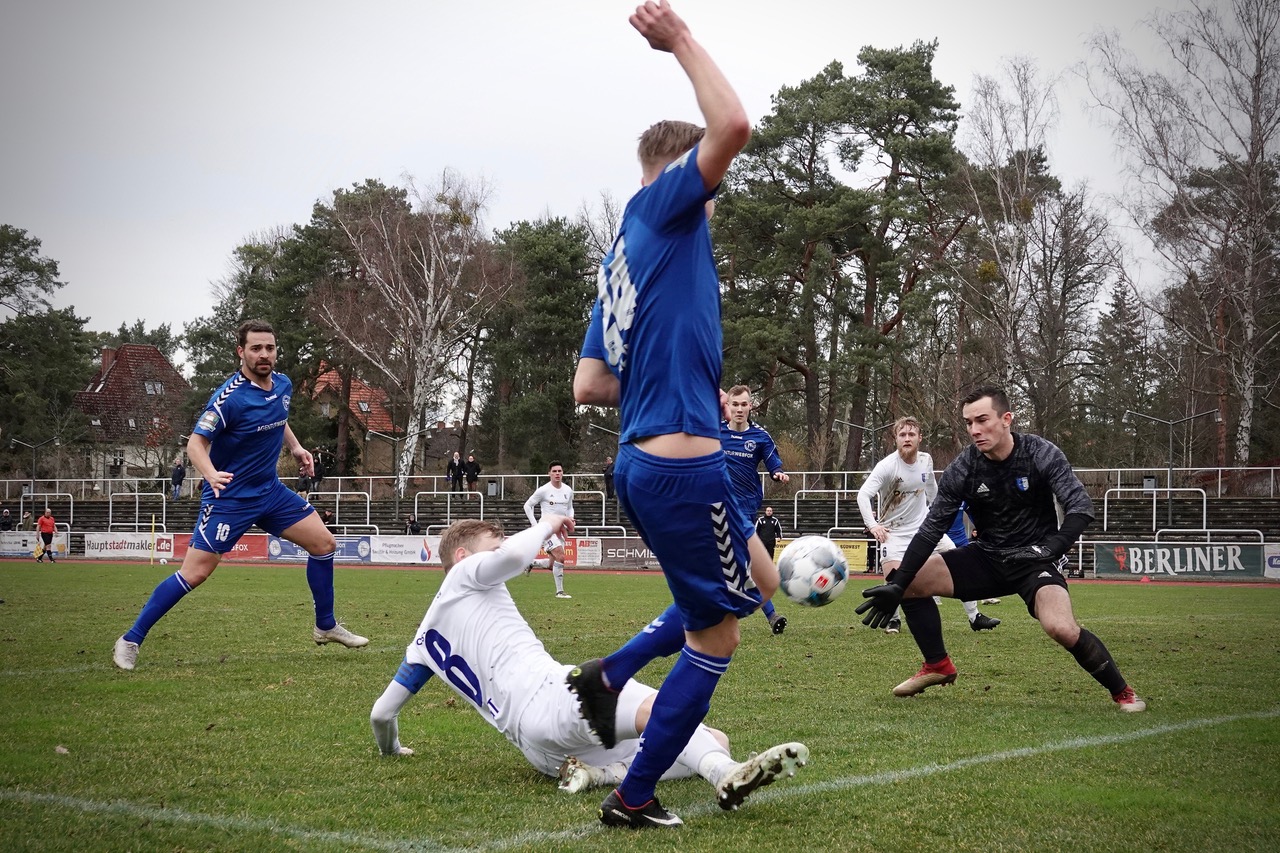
top-left (515, 666), bottom-right (694, 779)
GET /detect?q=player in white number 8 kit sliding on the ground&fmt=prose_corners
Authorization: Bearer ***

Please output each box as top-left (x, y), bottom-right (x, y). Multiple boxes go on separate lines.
top-left (370, 514), bottom-right (808, 809)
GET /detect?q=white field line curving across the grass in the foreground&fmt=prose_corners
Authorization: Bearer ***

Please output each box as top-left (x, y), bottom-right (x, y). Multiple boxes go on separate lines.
top-left (0, 708), bottom-right (1280, 853)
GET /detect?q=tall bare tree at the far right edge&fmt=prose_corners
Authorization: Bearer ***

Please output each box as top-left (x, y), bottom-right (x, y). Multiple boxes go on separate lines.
top-left (1084, 0), bottom-right (1280, 465)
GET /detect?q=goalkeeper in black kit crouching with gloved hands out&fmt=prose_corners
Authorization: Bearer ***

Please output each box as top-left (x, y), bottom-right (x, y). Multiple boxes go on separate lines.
top-left (856, 386), bottom-right (1147, 712)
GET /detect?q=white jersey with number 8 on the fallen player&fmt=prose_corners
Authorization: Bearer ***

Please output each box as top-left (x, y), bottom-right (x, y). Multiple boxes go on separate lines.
top-left (404, 524), bottom-right (560, 747)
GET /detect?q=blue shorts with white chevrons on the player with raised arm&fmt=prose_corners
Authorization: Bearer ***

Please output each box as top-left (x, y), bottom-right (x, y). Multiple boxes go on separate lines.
top-left (613, 444), bottom-right (760, 631)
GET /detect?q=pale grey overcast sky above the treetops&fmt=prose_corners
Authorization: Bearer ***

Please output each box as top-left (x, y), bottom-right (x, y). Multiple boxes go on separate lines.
top-left (0, 0), bottom-right (1169, 332)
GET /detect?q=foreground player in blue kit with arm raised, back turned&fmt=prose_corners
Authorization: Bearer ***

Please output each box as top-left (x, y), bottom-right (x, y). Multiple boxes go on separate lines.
top-left (567, 0), bottom-right (798, 827)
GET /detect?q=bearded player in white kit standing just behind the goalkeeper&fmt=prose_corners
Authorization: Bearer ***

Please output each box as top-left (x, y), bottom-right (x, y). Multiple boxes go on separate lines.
top-left (858, 418), bottom-right (1000, 634)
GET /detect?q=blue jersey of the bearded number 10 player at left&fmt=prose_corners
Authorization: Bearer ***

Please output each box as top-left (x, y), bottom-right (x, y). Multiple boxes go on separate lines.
top-left (192, 370), bottom-right (293, 502)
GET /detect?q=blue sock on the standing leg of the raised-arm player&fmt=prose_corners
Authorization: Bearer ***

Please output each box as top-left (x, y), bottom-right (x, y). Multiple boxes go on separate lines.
top-left (618, 646), bottom-right (731, 808)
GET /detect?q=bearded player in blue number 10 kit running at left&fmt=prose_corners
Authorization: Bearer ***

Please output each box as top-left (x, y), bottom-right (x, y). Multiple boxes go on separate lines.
top-left (111, 320), bottom-right (369, 670)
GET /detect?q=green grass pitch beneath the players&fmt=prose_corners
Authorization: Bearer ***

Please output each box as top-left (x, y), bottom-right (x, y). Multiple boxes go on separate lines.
top-left (0, 562), bottom-right (1280, 853)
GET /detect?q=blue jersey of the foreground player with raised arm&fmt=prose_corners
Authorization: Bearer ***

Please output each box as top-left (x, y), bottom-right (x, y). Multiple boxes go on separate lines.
top-left (581, 147), bottom-right (723, 444)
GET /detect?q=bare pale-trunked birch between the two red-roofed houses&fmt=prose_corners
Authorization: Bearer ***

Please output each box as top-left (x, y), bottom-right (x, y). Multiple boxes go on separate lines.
top-left (311, 172), bottom-right (500, 493)
